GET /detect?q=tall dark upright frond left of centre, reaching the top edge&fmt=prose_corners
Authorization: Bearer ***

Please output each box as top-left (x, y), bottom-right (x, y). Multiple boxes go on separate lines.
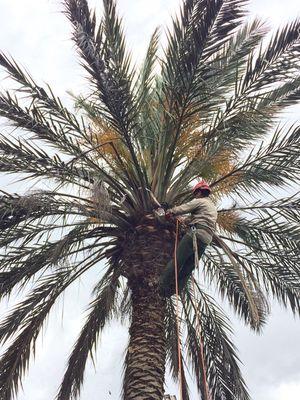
top-left (65, 0), bottom-right (149, 205)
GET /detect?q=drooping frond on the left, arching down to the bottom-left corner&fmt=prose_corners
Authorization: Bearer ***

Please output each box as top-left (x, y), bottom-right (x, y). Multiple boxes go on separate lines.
top-left (0, 252), bottom-right (103, 400)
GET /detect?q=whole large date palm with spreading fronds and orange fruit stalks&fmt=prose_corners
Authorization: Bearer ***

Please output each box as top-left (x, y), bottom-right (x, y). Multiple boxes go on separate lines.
top-left (0, 0), bottom-right (300, 400)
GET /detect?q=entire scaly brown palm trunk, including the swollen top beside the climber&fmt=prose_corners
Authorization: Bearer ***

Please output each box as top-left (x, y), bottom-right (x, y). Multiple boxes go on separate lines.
top-left (123, 222), bottom-right (174, 400)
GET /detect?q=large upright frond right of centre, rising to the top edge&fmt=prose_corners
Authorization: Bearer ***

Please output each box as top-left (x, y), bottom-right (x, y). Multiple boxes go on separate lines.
top-left (157, 0), bottom-right (244, 198)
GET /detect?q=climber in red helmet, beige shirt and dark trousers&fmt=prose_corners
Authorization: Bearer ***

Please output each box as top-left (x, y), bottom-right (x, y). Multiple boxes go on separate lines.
top-left (160, 180), bottom-right (217, 297)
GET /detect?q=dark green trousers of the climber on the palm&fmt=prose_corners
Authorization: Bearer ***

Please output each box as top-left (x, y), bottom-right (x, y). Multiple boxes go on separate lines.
top-left (160, 233), bottom-right (207, 297)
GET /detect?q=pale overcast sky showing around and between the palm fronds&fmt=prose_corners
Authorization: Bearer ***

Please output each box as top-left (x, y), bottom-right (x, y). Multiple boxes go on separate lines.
top-left (0, 0), bottom-right (300, 400)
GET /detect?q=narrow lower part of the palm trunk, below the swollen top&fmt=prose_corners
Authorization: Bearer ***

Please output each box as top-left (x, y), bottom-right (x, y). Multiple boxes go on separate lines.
top-left (124, 282), bottom-right (166, 400)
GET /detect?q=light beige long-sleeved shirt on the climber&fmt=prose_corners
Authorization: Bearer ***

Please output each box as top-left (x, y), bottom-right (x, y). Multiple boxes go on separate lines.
top-left (169, 197), bottom-right (218, 244)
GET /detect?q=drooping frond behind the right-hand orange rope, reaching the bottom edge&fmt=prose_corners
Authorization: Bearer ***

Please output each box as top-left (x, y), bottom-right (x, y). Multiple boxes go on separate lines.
top-left (183, 283), bottom-right (250, 400)
